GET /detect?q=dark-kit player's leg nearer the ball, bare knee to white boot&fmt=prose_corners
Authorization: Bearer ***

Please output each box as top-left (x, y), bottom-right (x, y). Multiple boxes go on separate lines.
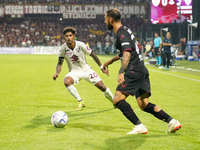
top-left (113, 91), bottom-right (148, 134)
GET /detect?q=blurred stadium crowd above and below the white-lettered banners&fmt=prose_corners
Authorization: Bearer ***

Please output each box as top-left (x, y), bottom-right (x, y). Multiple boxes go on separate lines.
top-left (0, 0), bottom-right (148, 53)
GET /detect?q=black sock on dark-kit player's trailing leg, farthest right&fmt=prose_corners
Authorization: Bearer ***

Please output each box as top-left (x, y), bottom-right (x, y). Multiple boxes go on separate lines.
top-left (144, 103), bottom-right (173, 123)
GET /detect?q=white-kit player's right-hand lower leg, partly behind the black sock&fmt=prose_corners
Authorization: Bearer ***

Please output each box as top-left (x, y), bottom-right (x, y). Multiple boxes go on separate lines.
top-left (95, 81), bottom-right (115, 107)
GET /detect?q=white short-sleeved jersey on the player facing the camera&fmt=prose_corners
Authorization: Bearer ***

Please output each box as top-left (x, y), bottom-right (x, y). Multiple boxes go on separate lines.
top-left (58, 41), bottom-right (92, 71)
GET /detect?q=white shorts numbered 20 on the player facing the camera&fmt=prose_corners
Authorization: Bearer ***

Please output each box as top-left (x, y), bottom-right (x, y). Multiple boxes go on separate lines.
top-left (65, 69), bottom-right (101, 85)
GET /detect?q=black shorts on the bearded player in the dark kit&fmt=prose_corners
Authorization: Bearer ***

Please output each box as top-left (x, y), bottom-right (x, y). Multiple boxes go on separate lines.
top-left (116, 71), bottom-right (151, 98)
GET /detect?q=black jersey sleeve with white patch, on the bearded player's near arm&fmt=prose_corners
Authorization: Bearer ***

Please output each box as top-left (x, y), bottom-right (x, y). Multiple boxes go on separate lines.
top-left (119, 35), bottom-right (132, 53)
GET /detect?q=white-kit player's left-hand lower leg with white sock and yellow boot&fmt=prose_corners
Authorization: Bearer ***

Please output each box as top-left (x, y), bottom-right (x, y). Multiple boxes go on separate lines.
top-left (64, 76), bottom-right (85, 110)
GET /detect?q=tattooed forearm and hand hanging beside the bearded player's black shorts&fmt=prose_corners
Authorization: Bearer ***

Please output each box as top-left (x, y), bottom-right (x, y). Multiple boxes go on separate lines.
top-left (118, 51), bottom-right (131, 85)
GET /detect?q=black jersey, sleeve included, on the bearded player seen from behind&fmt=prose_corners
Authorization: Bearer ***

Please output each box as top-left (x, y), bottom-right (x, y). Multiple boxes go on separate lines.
top-left (115, 26), bottom-right (147, 73)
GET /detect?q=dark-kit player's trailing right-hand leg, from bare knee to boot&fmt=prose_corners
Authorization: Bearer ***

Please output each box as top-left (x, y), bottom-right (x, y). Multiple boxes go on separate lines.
top-left (137, 93), bottom-right (181, 133)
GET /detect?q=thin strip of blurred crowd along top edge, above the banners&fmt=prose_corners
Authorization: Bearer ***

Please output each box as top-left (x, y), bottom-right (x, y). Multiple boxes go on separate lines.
top-left (0, 0), bottom-right (148, 4)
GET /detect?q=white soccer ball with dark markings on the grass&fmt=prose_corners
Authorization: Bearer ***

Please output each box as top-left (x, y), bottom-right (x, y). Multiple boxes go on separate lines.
top-left (51, 111), bottom-right (68, 128)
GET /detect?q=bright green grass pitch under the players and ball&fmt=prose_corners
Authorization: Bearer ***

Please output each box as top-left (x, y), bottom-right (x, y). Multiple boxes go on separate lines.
top-left (0, 55), bottom-right (200, 150)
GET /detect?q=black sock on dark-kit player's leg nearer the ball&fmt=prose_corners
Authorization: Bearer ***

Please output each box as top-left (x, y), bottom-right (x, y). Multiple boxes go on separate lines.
top-left (115, 100), bottom-right (141, 125)
